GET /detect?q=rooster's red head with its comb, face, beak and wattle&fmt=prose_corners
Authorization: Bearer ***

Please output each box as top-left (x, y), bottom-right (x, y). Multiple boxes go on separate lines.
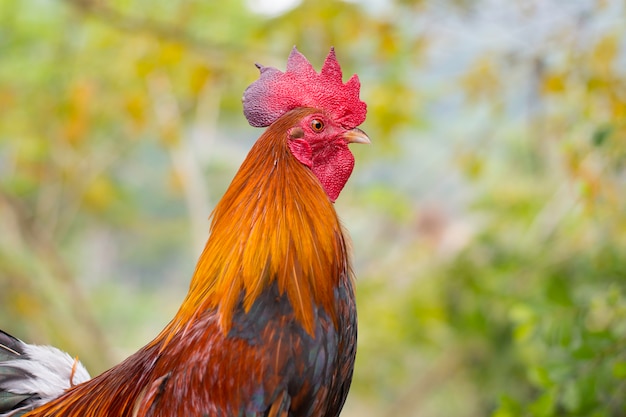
top-left (242, 47), bottom-right (370, 202)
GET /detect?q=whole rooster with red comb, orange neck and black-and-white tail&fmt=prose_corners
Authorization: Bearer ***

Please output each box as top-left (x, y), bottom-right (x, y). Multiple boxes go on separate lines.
top-left (0, 47), bottom-right (369, 417)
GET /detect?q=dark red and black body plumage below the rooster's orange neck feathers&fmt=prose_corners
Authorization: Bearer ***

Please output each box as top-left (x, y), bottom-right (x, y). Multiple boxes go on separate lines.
top-left (138, 277), bottom-right (356, 417)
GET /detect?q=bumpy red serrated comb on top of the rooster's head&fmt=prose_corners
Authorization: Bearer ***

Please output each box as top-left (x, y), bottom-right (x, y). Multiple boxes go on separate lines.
top-left (242, 46), bottom-right (367, 129)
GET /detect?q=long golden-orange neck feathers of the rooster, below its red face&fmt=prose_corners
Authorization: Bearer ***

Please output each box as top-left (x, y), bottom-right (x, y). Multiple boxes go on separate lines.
top-left (170, 109), bottom-right (349, 333)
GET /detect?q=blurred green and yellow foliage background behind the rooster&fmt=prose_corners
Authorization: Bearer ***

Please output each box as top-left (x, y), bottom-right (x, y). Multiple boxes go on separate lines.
top-left (0, 0), bottom-right (626, 417)
